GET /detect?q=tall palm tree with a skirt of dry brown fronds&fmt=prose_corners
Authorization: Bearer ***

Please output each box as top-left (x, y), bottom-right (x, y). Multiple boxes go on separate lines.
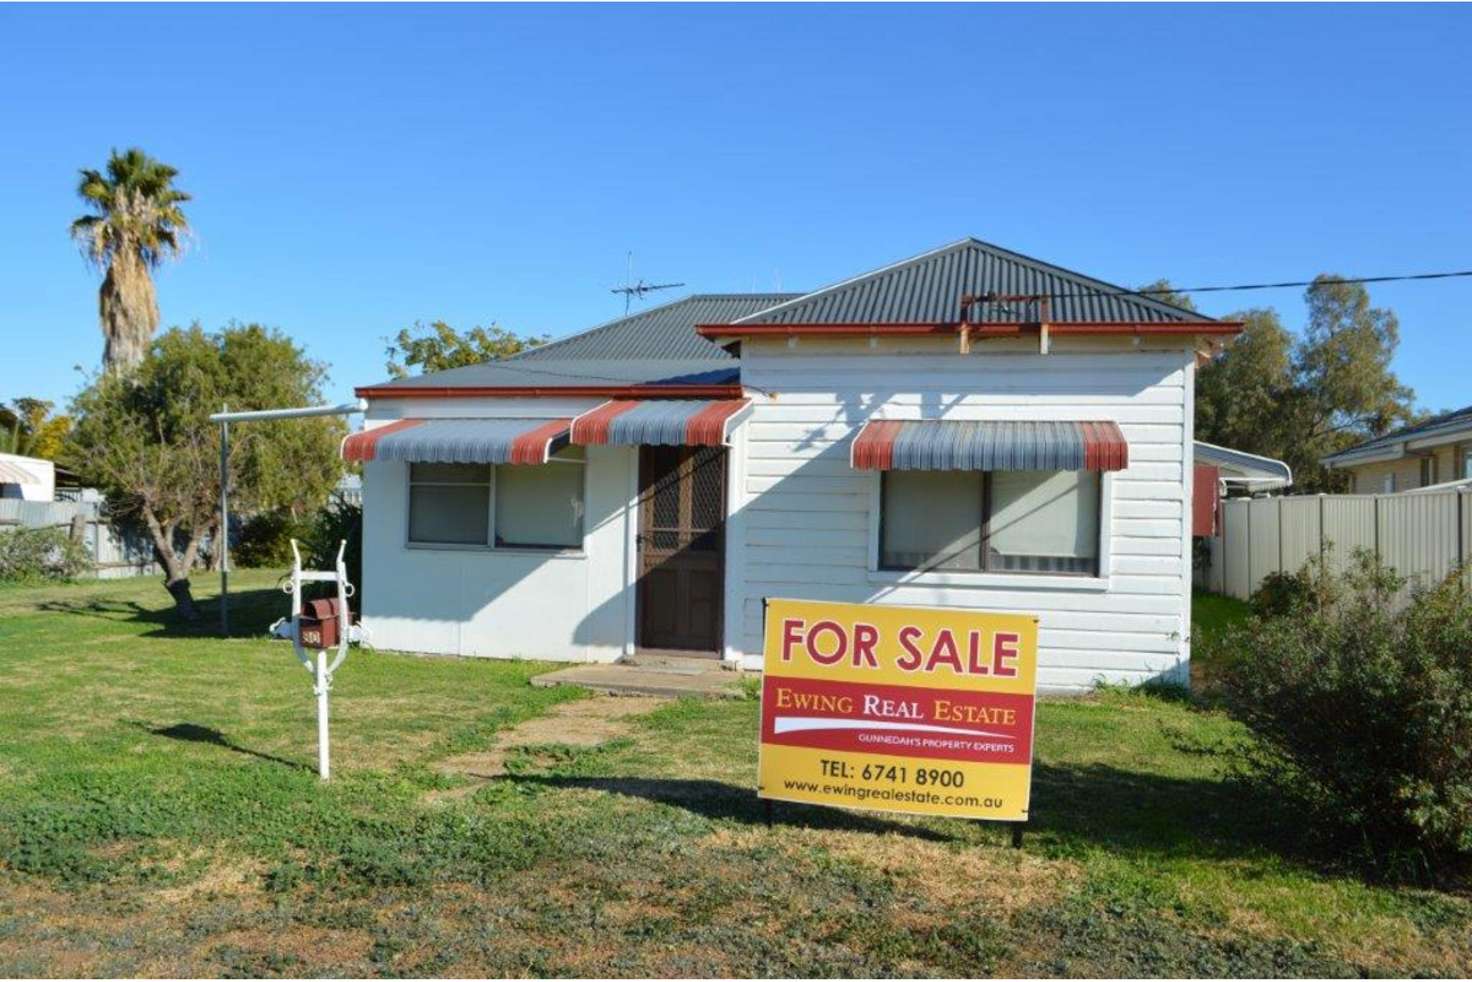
top-left (72, 147), bottom-right (190, 371)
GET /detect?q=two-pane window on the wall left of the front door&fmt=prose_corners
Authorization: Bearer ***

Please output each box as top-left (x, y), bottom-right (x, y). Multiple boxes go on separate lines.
top-left (409, 448), bottom-right (584, 549)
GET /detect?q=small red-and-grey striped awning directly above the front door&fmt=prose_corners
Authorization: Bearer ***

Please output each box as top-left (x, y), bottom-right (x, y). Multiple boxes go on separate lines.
top-left (573, 399), bottom-right (751, 446)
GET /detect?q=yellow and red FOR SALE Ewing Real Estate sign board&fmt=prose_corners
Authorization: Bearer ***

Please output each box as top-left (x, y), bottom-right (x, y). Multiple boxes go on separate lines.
top-left (757, 599), bottom-right (1038, 822)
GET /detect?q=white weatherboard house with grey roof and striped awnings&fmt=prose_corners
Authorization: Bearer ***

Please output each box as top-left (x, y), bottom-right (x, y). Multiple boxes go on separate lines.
top-left (353, 240), bottom-right (1239, 690)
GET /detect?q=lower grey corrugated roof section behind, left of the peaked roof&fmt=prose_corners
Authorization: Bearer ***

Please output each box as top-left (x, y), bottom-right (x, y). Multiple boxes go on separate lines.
top-left (506, 293), bottom-right (802, 362)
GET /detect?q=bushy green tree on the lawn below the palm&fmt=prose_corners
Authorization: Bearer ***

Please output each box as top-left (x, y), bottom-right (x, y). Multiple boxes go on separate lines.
top-left (65, 324), bottom-right (346, 620)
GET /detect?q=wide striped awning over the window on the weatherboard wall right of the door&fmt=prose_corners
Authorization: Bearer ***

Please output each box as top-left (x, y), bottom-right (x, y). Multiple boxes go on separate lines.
top-left (849, 420), bottom-right (1129, 471)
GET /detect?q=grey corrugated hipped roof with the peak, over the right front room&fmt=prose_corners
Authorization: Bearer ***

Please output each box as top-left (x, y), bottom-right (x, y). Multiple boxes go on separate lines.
top-left (733, 239), bottom-right (1211, 324)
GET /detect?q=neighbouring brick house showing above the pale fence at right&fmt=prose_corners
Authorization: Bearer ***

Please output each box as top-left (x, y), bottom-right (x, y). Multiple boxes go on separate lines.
top-left (1320, 406), bottom-right (1472, 495)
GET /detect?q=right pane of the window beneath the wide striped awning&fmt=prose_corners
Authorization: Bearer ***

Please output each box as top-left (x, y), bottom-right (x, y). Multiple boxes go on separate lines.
top-left (989, 471), bottom-right (1100, 573)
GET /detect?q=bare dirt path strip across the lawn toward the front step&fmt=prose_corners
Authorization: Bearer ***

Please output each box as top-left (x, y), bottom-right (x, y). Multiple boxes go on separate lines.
top-left (430, 695), bottom-right (665, 799)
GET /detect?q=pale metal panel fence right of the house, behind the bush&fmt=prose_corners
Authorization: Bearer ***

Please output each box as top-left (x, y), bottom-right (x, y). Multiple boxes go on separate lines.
top-left (1206, 489), bottom-right (1472, 599)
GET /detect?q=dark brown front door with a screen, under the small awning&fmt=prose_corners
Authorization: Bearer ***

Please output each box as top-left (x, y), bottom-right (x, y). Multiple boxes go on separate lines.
top-left (636, 446), bottom-right (726, 652)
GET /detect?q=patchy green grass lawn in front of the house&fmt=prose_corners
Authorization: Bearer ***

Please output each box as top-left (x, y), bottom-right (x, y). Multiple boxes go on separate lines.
top-left (0, 573), bottom-right (1472, 976)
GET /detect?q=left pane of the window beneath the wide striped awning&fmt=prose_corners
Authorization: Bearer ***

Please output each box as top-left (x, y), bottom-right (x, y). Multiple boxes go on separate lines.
top-left (880, 471), bottom-right (982, 570)
